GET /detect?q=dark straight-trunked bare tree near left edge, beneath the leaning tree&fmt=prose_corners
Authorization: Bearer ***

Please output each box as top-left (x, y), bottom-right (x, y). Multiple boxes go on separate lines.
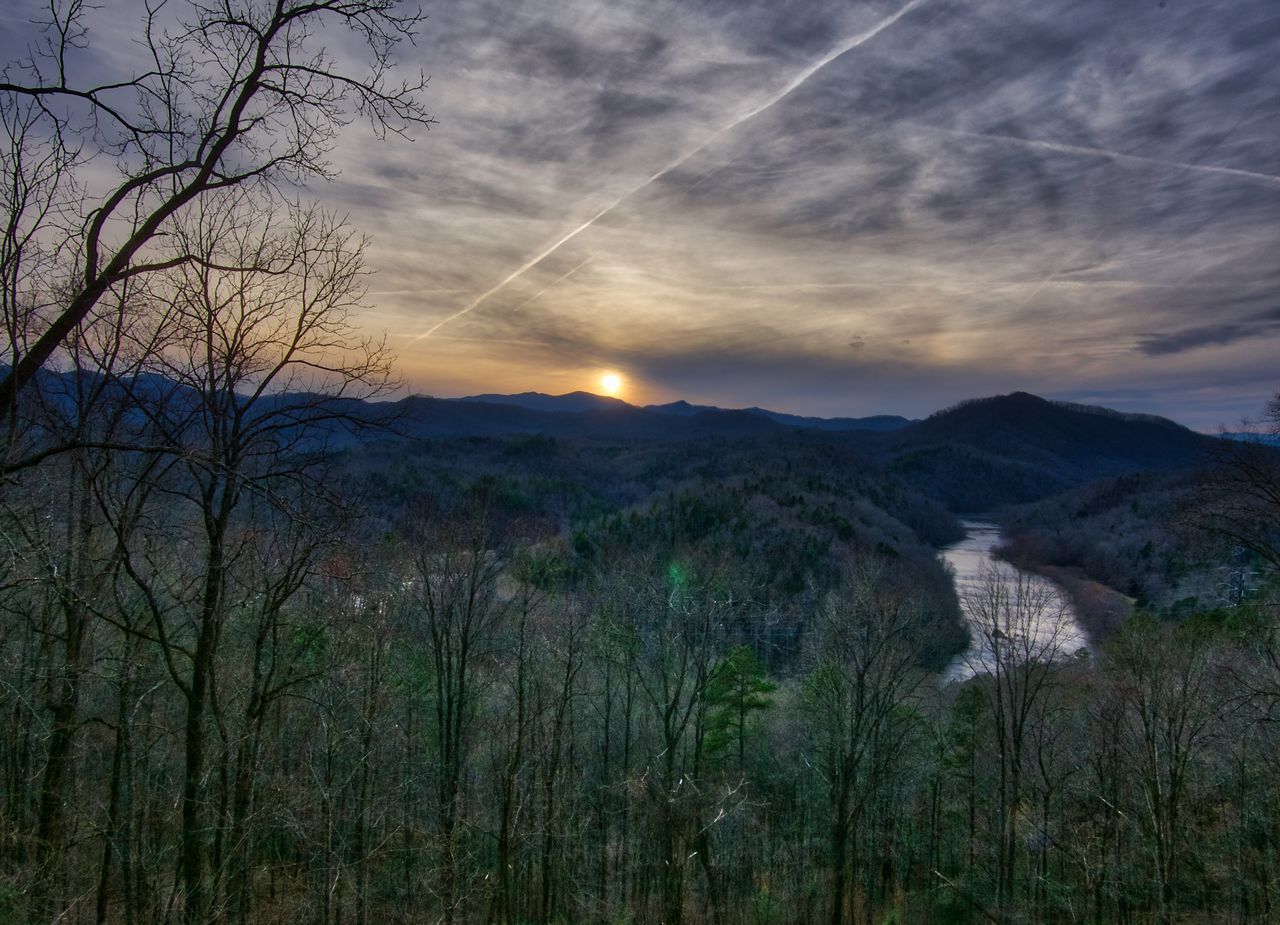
top-left (0, 284), bottom-right (186, 916)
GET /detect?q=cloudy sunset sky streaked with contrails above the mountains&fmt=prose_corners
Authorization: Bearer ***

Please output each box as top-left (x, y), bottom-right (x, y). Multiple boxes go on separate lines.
top-left (2, 0), bottom-right (1280, 430)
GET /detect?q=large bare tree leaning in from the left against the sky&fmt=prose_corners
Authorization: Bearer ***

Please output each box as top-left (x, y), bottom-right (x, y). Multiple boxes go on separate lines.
top-left (0, 0), bottom-right (431, 409)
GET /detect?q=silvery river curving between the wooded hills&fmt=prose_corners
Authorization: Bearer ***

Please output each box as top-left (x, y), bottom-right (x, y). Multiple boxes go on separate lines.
top-left (942, 521), bottom-right (1089, 681)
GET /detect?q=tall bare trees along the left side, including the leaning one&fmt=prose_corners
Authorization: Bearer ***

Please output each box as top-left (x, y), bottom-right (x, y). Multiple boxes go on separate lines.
top-left (0, 0), bottom-right (429, 905)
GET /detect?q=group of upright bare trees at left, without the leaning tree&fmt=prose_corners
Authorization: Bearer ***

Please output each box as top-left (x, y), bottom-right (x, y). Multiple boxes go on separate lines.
top-left (5, 184), bottom-right (389, 922)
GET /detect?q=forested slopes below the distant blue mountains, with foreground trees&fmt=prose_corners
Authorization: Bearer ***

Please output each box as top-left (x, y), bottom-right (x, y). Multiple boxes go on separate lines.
top-left (0, 365), bottom-right (1280, 925)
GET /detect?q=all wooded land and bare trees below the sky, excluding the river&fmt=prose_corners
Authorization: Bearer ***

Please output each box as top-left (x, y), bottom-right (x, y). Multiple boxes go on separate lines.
top-left (0, 0), bottom-right (1280, 925)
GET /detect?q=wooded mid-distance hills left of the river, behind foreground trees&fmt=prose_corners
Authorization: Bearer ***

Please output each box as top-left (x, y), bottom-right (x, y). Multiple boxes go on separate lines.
top-left (337, 431), bottom-right (965, 667)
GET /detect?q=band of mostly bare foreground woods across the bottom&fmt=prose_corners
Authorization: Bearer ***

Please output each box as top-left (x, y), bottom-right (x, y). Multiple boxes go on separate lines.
top-left (0, 452), bottom-right (1280, 924)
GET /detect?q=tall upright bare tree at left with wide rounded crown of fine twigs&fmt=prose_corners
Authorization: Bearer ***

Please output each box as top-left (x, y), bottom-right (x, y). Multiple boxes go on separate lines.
top-left (101, 191), bottom-right (392, 922)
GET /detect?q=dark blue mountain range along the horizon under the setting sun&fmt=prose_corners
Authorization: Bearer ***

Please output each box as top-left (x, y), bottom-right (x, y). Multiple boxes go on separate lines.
top-left (7, 374), bottom-right (1221, 512)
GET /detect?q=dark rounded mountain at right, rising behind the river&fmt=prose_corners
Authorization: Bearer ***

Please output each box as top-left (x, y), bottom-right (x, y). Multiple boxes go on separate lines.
top-left (868, 391), bottom-right (1216, 512)
